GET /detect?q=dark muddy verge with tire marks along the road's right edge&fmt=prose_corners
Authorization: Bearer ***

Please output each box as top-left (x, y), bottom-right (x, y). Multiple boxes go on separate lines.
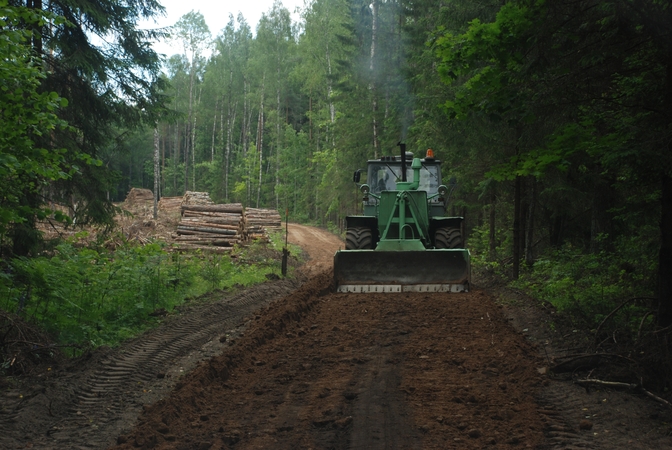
top-left (496, 289), bottom-right (672, 450)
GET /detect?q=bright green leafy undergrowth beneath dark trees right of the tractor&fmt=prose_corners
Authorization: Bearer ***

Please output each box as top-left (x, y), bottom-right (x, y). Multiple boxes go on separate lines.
top-left (469, 221), bottom-right (657, 337)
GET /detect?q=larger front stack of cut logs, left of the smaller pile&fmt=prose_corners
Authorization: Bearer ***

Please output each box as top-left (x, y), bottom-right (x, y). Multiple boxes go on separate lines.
top-left (174, 203), bottom-right (244, 252)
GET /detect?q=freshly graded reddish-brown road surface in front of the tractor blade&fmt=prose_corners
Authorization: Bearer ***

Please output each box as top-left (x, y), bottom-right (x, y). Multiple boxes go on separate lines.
top-left (110, 273), bottom-right (544, 449)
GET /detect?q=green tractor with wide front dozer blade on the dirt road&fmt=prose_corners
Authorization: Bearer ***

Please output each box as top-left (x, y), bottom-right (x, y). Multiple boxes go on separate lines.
top-left (334, 143), bottom-right (471, 292)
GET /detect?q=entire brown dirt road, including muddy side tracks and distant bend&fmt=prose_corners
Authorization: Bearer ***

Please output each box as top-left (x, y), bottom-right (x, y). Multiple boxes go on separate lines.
top-left (0, 225), bottom-right (672, 449)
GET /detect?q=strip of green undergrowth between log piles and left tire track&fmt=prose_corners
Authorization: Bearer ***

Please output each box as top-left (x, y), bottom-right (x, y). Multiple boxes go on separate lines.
top-left (0, 232), bottom-right (300, 356)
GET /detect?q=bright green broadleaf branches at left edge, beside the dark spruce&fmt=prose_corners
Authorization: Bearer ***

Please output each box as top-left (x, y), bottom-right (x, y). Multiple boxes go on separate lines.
top-left (0, 1), bottom-right (73, 238)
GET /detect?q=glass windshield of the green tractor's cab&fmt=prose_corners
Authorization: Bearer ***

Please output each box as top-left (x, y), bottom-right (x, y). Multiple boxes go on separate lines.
top-left (367, 162), bottom-right (441, 195)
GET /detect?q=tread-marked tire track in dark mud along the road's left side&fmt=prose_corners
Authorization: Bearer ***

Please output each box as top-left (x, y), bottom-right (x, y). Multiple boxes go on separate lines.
top-left (0, 280), bottom-right (298, 449)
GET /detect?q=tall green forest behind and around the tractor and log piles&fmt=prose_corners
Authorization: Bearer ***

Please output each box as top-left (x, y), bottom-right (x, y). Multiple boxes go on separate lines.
top-left (0, 0), bottom-right (672, 370)
